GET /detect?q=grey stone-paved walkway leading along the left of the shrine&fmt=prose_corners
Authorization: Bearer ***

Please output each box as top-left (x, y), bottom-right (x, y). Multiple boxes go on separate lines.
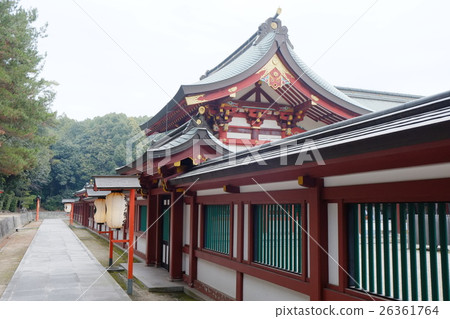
top-left (0, 219), bottom-right (130, 301)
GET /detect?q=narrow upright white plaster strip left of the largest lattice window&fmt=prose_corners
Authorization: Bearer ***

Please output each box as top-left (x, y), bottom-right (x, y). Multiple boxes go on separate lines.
top-left (328, 203), bottom-right (339, 285)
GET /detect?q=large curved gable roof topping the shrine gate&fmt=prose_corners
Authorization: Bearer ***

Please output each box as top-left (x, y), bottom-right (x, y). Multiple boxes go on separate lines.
top-left (140, 15), bottom-right (371, 130)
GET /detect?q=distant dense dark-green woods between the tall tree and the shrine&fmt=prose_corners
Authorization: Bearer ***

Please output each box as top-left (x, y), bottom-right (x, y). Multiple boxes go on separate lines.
top-left (42, 113), bottom-right (148, 210)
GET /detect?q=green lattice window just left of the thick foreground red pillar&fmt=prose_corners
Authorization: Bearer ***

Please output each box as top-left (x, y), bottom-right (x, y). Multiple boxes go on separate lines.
top-left (253, 204), bottom-right (302, 273)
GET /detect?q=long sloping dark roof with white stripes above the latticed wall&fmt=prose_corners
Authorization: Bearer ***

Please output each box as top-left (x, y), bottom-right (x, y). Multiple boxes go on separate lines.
top-left (170, 91), bottom-right (450, 185)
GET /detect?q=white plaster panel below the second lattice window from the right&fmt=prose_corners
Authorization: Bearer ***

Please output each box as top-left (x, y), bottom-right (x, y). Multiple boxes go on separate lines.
top-left (243, 275), bottom-right (309, 301)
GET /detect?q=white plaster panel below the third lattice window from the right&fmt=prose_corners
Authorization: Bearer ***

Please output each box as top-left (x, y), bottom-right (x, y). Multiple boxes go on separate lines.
top-left (197, 259), bottom-right (236, 298)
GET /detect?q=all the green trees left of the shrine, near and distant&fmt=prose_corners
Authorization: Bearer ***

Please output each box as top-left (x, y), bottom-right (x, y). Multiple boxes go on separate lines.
top-left (0, 0), bottom-right (148, 210)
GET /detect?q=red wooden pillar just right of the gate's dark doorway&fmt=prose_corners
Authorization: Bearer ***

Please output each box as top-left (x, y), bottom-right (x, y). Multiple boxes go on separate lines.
top-left (169, 192), bottom-right (183, 280)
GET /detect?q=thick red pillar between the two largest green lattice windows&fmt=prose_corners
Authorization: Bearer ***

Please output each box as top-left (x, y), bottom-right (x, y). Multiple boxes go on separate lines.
top-left (309, 180), bottom-right (328, 301)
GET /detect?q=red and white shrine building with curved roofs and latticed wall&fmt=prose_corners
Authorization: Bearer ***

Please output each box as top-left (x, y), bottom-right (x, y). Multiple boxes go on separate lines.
top-left (75, 14), bottom-right (450, 301)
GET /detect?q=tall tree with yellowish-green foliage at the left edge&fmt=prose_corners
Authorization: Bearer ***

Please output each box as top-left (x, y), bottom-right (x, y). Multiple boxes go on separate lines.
top-left (0, 0), bottom-right (55, 176)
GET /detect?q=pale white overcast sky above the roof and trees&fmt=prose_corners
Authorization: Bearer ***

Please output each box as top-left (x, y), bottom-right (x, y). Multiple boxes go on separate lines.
top-left (21, 0), bottom-right (450, 120)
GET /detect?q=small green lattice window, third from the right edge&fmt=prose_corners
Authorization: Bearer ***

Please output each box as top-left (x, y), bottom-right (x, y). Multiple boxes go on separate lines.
top-left (203, 205), bottom-right (230, 254)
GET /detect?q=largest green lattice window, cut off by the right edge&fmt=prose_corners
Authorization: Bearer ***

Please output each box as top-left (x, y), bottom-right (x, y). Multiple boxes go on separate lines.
top-left (348, 203), bottom-right (450, 300)
